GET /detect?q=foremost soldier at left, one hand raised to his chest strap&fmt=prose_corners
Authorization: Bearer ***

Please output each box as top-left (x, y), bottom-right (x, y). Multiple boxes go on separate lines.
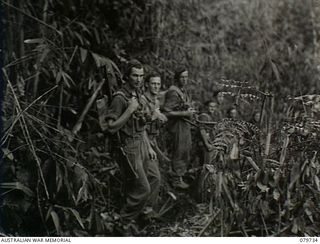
top-left (106, 61), bottom-right (160, 219)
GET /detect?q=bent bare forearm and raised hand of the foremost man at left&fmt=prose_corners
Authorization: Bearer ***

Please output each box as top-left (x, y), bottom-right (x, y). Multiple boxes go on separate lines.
top-left (107, 97), bottom-right (139, 133)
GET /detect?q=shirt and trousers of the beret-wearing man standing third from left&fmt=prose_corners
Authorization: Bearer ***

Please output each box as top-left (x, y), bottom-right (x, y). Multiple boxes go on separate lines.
top-left (163, 86), bottom-right (192, 176)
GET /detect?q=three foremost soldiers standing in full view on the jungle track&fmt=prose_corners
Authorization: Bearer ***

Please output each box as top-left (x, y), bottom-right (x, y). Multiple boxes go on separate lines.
top-left (106, 61), bottom-right (205, 220)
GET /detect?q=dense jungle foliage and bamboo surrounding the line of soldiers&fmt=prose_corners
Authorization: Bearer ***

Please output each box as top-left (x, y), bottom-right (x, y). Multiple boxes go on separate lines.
top-left (1, 0), bottom-right (320, 236)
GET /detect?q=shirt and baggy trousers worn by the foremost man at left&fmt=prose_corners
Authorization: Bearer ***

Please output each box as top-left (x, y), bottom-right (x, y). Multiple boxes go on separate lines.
top-left (106, 86), bottom-right (160, 219)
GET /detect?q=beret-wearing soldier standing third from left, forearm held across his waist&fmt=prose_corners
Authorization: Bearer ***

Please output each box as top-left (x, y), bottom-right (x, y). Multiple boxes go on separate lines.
top-left (163, 68), bottom-right (195, 189)
